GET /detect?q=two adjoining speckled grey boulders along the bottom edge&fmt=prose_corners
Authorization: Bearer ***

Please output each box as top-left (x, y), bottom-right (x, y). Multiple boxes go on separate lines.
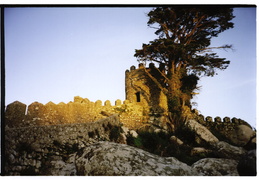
top-left (75, 142), bottom-right (247, 176)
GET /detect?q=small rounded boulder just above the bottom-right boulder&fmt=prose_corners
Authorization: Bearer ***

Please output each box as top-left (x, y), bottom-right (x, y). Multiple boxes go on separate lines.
top-left (212, 141), bottom-right (246, 160)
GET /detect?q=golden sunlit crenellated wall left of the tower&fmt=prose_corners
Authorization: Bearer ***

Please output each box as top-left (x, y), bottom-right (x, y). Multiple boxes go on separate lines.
top-left (5, 96), bottom-right (148, 129)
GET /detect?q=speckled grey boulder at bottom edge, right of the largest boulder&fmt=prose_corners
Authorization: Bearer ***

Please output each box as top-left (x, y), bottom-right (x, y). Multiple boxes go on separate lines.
top-left (192, 158), bottom-right (239, 176)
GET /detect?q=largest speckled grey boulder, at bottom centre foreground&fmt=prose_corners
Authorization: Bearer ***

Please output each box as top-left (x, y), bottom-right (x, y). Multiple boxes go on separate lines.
top-left (75, 142), bottom-right (199, 176)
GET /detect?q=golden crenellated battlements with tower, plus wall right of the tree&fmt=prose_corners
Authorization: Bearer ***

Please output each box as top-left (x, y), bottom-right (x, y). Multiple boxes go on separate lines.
top-left (5, 63), bottom-right (255, 146)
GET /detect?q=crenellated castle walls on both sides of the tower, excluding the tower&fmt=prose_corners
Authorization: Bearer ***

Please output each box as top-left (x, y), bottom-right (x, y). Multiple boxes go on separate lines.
top-left (5, 96), bottom-right (251, 144)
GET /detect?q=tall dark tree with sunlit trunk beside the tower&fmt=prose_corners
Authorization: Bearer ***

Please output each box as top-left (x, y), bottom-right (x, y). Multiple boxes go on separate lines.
top-left (134, 6), bottom-right (234, 123)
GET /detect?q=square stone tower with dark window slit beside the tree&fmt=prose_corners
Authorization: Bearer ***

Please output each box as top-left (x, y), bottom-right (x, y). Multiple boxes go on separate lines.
top-left (125, 63), bottom-right (168, 114)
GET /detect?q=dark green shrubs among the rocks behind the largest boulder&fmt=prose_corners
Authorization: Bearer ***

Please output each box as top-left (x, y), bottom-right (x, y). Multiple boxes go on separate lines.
top-left (127, 126), bottom-right (221, 165)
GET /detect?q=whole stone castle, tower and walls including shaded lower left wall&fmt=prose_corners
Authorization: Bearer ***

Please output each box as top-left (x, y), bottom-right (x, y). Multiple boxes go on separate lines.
top-left (5, 63), bottom-right (256, 175)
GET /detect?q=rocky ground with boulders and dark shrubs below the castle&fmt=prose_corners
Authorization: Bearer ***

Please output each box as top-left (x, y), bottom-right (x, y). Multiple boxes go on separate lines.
top-left (4, 116), bottom-right (256, 176)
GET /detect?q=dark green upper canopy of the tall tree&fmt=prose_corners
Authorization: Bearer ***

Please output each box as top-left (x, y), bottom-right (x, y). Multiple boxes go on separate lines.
top-left (138, 6), bottom-right (234, 71)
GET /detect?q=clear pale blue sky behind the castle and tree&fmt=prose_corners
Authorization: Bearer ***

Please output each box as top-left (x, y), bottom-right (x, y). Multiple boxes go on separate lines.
top-left (5, 7), bottom-right (256, 127)
